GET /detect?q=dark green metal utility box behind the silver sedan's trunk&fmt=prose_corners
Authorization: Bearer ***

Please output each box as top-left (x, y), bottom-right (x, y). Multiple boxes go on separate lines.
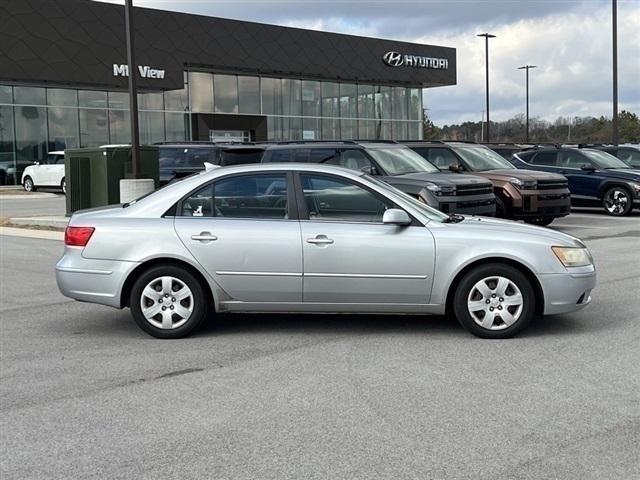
top-left (64, 145), bottom-right (159, 216)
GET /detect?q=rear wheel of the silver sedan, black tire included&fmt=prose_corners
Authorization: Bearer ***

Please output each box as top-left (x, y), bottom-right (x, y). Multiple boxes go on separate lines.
top-left (129, 265), bottom-right (209, 338)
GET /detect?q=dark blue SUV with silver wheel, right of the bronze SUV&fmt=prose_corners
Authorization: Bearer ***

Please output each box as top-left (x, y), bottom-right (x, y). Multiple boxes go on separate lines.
top-left (512, 147), bottom-right (640, 216)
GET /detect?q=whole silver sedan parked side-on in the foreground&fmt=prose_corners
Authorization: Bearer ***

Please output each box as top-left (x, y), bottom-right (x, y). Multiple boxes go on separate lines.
top-left (56, 164), bottom-right (596, 338)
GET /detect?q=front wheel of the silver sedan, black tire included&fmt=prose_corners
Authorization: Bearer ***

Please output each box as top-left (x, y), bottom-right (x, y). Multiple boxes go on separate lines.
top-left (453, 263), bottom-right (536, 338)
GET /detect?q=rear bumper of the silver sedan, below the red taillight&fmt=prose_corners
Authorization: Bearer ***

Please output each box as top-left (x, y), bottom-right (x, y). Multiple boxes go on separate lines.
top-left (56, 247), bottom-right (139, 308)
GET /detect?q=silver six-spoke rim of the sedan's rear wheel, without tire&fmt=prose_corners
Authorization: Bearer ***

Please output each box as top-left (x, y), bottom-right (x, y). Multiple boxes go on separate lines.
top-left (140, 276), bottom-right (194, 330)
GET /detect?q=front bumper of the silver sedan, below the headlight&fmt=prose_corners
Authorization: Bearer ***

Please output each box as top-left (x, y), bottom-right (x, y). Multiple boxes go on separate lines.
top-left (538, 266), bottom-right (596, 315)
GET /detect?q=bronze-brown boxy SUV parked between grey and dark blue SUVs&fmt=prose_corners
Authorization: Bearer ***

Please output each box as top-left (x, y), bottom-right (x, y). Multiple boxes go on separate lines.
top-left (402, 141), bottom-right (571, 225)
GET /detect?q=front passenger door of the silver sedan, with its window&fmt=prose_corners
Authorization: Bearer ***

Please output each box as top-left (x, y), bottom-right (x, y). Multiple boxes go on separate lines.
top-left (299, 173), bottom-right (435, 310)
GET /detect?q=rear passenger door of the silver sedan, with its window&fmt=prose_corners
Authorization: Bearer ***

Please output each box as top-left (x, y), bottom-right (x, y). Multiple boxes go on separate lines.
top-left (175, 172), bottom-right (302, 302)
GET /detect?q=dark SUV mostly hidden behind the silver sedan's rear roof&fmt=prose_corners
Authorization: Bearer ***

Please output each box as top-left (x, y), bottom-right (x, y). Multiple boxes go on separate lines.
top-left (156, 142), bottom-right (264, 185)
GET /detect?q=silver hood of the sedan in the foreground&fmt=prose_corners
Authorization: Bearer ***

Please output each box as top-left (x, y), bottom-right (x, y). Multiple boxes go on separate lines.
top-left (452, 216), bottom-right (584, 247)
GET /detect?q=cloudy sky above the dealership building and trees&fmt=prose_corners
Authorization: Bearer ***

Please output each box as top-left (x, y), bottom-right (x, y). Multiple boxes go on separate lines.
top-left (97, 0), bottom-right (640, 125)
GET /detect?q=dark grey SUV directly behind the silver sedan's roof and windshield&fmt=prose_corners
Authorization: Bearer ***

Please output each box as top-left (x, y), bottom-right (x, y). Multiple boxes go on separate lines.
top-left (262, 141), bottom-right (495, 216)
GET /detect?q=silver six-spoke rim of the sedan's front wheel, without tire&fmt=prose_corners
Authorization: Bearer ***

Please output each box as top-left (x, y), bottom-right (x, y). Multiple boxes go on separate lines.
top-left (467, 276), bottom-right (523, 330)
